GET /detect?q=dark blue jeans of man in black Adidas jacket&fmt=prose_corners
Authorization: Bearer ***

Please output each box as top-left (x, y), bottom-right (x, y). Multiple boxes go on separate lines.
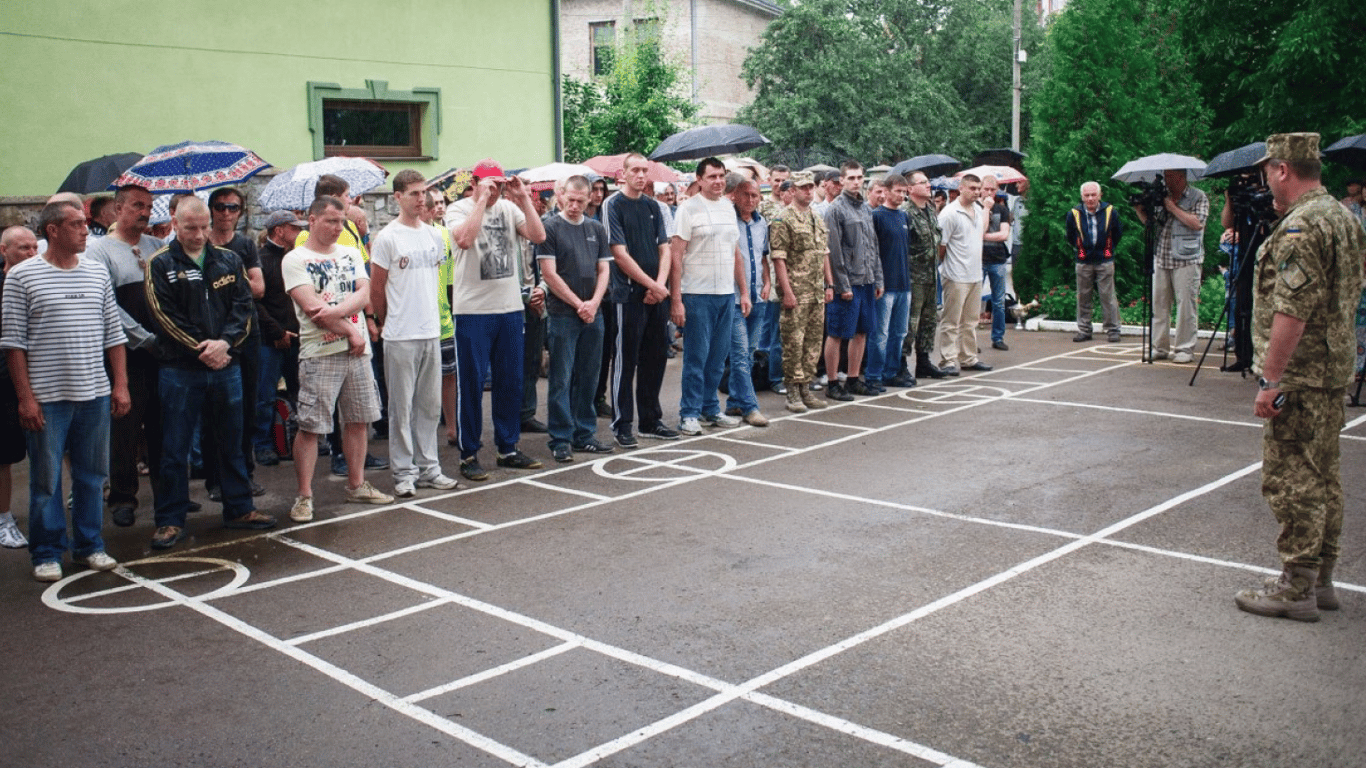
top-left (156, 362), bottom-right (255, 527)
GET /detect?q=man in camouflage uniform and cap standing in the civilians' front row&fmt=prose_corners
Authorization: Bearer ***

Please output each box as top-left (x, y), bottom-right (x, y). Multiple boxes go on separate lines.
top-left (769, 171), bottom-right (835, 413)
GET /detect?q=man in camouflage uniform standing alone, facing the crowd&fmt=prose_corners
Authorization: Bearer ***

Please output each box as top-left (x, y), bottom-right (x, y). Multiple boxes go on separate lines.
top-left (1233, 134), bottom-right (1366, 622)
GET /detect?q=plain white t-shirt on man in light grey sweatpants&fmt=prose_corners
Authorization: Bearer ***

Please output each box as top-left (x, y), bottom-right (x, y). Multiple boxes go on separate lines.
top-left (370, 219), bottom-right (445, 342)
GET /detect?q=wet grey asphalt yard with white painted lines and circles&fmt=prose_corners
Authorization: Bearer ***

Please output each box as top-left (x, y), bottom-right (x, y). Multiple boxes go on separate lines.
top-left (0, 332), bottom-right (1366, 768)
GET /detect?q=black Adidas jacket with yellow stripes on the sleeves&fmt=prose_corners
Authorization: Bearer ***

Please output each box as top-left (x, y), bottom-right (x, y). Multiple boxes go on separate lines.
top-left (146, 241), bottom-right (255, 370)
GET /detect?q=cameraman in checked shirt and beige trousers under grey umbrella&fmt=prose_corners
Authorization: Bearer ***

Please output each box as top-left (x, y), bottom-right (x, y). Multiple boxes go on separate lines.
top-left (1134, 171), bottom-right (1209, 362)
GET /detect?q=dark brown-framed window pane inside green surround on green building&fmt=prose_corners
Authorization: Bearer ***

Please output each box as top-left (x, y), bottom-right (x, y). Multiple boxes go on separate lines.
top-left (322, 98), bottom-right (422, 157)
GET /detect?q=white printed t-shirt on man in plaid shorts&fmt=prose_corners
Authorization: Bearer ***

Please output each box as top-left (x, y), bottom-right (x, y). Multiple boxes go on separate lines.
top-left (280, 245), bottom-right (370, 359)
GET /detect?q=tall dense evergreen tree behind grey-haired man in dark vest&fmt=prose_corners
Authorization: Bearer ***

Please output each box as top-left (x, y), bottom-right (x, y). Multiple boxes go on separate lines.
top-left (1015, 0), bottom-right (1217, 298)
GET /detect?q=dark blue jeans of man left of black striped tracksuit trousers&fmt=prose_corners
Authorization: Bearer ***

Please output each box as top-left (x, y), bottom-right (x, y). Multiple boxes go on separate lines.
top-left (545, 312), bottom-right (605, 448)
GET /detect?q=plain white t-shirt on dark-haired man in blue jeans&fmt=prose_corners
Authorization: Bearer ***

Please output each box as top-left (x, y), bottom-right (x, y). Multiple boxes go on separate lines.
top-left (675, 195), bottom-right (740, 294)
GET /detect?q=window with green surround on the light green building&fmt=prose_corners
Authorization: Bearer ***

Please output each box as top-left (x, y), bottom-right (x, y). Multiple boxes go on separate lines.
top-left (307, 81), bottom-right (441, 160)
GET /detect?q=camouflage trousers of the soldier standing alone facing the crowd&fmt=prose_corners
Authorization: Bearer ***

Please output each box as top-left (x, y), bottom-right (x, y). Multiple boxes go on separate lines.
top-left (1262, 388), bottom-right (1347, 568)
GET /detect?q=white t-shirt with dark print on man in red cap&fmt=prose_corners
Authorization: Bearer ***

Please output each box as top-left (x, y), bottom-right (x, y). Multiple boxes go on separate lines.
top-left (445, 197), bottom-right (526, 314)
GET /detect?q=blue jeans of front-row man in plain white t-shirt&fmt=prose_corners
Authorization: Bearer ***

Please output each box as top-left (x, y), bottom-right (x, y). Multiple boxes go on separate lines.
top-left (679, 294), bottom-right (735, 418)
